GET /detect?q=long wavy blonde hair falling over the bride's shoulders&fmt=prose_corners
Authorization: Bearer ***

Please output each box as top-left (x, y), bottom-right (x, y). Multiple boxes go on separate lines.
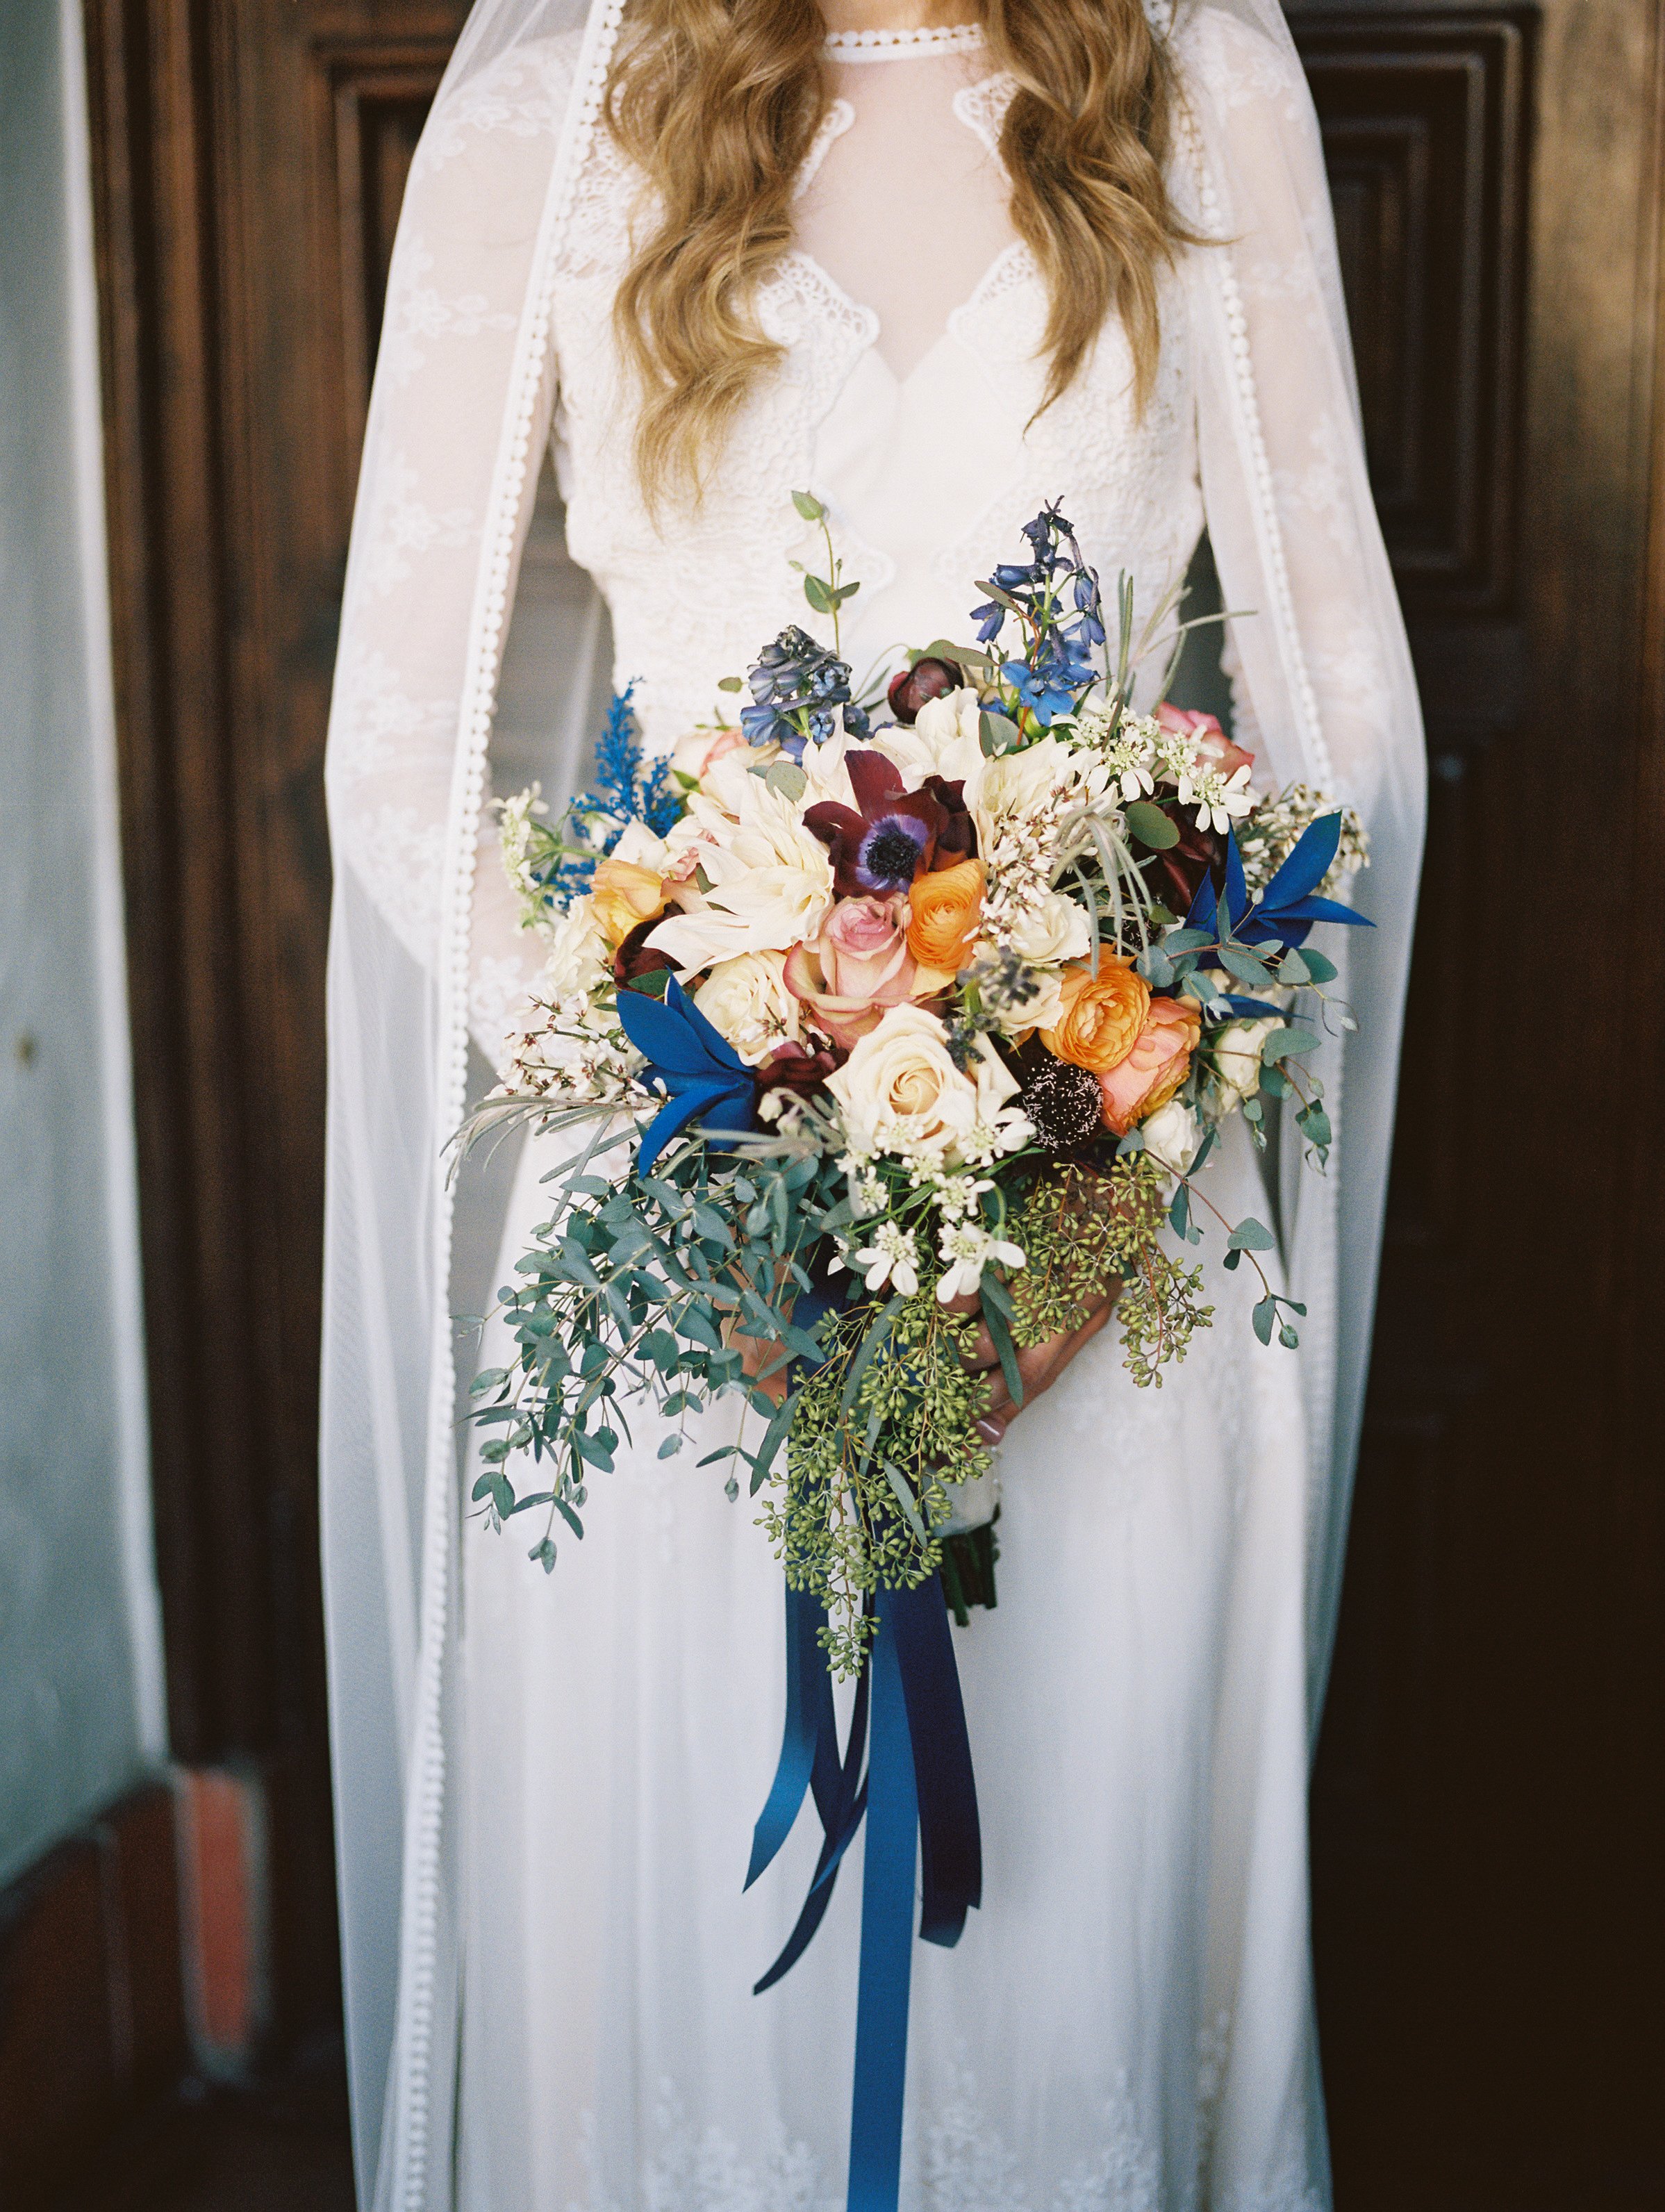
top-left (606, 0), bottom-right (1190, 502)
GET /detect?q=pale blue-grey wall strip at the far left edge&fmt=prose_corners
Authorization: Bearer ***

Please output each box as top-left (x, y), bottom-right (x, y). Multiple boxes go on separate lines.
top-left (0, 0), bottom-right (164, 1880)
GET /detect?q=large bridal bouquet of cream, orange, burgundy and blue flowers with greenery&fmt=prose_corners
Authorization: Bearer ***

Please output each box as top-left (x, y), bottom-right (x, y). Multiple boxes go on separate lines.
top-left (469, 495), bottom-right (1366, 1672)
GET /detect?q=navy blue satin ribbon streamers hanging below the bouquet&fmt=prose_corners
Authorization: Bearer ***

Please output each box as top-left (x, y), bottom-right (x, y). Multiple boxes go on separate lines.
top-left (745, 1575), bottom-right (981, 2212)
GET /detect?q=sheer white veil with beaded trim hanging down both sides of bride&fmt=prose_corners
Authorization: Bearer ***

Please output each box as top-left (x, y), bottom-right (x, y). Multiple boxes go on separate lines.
top-left (321, 0), bottom-right (1422, 2212)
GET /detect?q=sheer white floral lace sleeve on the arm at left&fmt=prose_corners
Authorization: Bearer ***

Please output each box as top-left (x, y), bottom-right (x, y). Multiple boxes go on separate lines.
top-left (325, 42), bottom-right (570, 1059)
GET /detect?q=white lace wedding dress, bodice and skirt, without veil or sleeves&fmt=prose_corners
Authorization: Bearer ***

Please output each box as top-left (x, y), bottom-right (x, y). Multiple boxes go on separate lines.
top-left (454, 33), bottom-right (1327, 2212)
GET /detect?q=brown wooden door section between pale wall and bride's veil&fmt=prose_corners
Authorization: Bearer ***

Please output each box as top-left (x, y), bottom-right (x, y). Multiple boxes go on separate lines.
top-left (86, 0), bottom-right (467, 2033)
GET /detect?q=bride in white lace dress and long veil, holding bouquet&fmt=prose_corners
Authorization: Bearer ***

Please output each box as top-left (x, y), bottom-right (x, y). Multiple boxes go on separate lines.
top-left (323, 0), bottom-right (1422, 2212)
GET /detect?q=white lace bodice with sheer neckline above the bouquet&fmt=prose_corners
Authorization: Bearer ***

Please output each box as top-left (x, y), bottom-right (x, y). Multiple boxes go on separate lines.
top-left (553, 40), bottom-right (1203, 745)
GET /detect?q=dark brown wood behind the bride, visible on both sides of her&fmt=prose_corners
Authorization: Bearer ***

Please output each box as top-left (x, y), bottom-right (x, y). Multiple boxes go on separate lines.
top-left (86, 0), bottom-right (1665, 2212)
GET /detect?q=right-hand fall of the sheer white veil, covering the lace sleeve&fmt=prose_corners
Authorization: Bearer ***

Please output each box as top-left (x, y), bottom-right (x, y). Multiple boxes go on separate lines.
top-left (1172, 0), bottom-right (1424, 1715)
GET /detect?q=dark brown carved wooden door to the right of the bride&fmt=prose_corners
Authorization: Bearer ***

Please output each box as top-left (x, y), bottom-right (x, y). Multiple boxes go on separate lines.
top-left (1289, 0), bottom-right (1665, 2212)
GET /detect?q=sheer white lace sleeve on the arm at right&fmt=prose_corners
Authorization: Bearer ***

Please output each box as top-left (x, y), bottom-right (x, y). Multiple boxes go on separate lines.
top-left (1176, 0), bottom-right (1422, 820)
